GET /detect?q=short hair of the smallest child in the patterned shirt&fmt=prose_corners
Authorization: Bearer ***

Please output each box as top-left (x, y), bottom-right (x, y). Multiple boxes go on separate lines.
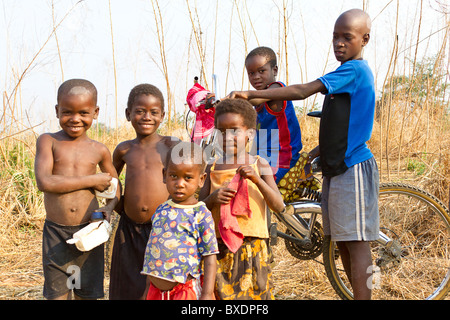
top-left (164, 141), bottom-right (207, 174)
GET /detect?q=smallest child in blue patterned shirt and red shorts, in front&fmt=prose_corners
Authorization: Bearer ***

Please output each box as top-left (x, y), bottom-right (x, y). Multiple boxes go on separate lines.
top-left (142, 142), bottom-right (218, 300)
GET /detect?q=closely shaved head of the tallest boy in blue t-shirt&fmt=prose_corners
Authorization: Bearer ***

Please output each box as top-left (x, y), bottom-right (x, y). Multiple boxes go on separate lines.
top-left (333, 9), bottom-right (371, 64)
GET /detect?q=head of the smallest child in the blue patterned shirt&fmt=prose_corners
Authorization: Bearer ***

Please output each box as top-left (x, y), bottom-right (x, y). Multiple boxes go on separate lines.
top-left (163, 142), bottom-right (206, 204)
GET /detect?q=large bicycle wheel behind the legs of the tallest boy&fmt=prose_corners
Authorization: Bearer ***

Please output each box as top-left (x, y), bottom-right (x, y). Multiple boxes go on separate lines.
top-left (323, 183), bottom-right (450, 300)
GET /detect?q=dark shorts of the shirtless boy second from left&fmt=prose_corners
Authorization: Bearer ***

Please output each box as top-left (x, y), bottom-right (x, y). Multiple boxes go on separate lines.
top-left (109, 213), bottom-right (152, 300)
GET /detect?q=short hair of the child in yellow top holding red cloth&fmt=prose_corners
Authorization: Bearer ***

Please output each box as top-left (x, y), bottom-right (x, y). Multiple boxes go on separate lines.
top-left (214, 99), bottom-right (257, 129)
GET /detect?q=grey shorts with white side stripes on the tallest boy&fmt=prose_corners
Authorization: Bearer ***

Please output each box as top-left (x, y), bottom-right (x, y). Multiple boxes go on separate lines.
top-left (322, 157), bottom-right (379, 241)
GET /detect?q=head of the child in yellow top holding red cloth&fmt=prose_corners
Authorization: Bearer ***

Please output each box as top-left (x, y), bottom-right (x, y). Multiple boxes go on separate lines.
top-left (214, 99), bottom-right (256, 158)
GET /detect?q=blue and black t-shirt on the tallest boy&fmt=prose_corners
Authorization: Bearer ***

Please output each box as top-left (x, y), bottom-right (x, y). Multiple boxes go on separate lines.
top-left (319, 60), bottom-right (375, 176)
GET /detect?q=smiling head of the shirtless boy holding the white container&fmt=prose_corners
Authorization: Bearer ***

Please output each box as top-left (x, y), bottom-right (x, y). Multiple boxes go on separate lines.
top-left (55, 79), bottom-right (99, 138)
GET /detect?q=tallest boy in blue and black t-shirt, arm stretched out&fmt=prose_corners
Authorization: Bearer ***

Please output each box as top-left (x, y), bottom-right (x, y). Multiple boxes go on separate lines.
top-left (229, 9), bottom-right (379, 299)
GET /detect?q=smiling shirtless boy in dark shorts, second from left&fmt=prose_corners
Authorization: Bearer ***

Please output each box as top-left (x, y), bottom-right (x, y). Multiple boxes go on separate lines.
top-left (109, 84), bottom-right (178, 300)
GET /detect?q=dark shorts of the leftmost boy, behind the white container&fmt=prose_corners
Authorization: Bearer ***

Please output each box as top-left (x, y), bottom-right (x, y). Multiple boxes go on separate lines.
top-left (42, 220), bottom-right (105, 299)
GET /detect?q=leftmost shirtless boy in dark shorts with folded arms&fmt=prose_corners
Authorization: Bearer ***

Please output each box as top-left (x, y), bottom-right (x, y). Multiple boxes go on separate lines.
top-left (35, 79), bottom-right (120, 299)
